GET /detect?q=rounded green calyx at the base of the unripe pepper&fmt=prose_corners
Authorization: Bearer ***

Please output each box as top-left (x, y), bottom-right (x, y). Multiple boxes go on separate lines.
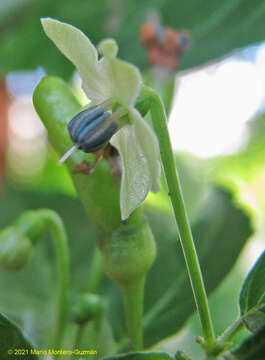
top-left (100, 218), bottom-right (156, 287)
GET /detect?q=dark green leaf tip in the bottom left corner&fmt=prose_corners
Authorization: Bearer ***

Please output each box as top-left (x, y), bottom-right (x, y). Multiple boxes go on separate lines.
top-left (0, 313), bottom-right (38, 360)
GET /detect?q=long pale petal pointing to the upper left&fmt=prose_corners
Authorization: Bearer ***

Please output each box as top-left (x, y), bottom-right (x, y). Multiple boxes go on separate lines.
top-left (41, 18), bottom-right (106, 101)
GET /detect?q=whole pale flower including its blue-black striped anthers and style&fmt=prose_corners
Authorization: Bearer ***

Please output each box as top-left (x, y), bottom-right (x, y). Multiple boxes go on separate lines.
top-left (41, 18), bottom-right (161, 220)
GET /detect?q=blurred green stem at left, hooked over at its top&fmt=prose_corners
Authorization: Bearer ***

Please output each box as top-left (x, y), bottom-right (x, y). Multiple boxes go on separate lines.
top-left (39, 209), bottom-right (69, 349)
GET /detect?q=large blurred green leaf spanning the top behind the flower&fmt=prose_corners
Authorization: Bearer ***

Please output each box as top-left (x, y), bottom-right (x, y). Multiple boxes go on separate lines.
top-left (0, 0), bottom-right (265, 78)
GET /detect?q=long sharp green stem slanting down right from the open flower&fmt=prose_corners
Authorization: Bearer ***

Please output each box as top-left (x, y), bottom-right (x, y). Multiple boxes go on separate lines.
top-left (150, 91), bottom-right (215, 347)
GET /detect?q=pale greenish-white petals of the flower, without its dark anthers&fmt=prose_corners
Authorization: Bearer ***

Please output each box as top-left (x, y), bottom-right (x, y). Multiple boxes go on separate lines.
top-left (41, 18), bottom-right (161, 220)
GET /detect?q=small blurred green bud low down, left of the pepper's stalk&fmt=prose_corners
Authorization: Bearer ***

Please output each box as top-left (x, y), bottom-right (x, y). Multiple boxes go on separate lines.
top-left (70, 293), bottom-right (105, 324)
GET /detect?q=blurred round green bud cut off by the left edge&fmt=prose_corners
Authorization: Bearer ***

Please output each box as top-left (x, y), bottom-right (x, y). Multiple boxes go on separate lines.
top-left (0, 226), bottom-right (33, 270)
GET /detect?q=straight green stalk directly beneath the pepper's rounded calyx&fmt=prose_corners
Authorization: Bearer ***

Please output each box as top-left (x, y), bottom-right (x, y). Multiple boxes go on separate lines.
top-left (122, 277), bottom-right (145, 351)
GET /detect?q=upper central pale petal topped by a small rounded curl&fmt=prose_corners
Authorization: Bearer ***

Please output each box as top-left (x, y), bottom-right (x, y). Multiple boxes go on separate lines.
top-left (99, 39), bottom-right (142, 107)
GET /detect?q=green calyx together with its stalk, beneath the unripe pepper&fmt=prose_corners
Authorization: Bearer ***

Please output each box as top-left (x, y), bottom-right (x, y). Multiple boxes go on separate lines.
top-left (100, 216), bottom-right (156, 350)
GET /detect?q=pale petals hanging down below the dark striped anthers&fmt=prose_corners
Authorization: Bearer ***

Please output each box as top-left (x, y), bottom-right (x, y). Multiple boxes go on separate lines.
top-left (111, 109), bottom-right (160, 220)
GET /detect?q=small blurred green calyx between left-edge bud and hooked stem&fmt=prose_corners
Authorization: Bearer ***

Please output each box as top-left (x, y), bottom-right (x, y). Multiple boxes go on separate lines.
top-left (15, 210), bottom-right (45, 244)
